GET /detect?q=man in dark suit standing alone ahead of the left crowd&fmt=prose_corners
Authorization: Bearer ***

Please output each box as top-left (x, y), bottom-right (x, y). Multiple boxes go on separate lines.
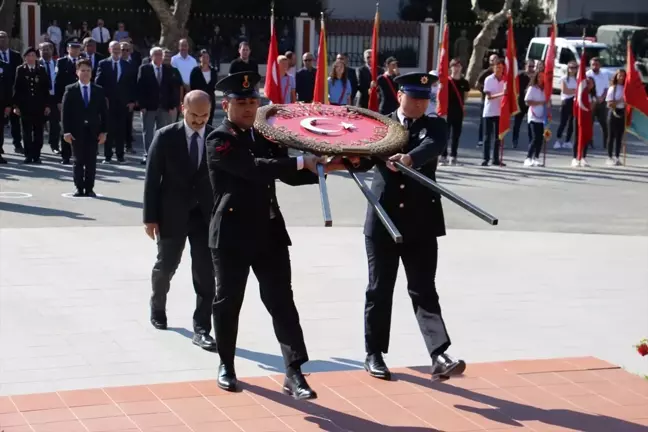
top-left (61, 59), bottom-right (108, 197)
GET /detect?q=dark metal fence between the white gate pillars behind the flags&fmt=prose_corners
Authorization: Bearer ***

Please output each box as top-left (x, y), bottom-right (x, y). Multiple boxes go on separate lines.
top-left (316, 19), bottom-right (421, 67)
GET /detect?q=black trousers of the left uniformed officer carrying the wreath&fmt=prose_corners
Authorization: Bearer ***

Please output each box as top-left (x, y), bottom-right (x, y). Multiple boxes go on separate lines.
top-left (212, 221), bottom-right (308, 368)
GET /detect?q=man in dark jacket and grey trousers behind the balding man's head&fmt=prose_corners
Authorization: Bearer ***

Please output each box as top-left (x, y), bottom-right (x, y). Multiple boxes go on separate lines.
top-left (137, 47), bottom-right (180, 164)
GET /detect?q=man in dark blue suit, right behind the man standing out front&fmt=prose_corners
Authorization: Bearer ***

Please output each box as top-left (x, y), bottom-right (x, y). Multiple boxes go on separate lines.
top-left (95, 41), bottom-right (136, 164)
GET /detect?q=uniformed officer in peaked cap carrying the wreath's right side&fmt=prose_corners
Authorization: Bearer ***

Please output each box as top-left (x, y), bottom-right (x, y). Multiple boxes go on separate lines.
top-left (350, 73), bottom-right (466, 379)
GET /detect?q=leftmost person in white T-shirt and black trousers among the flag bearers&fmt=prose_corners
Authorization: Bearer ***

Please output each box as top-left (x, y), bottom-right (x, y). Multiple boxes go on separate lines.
top-left (482, 59), bottom-right (506, 166)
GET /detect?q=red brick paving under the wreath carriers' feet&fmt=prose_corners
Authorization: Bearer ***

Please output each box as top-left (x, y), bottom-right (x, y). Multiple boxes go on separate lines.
top-left (0, 357), bottom-right (648, 432)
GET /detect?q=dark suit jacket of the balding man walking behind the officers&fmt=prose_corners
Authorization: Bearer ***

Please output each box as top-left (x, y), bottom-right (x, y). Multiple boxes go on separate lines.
top-left (144, 121), bottom-right (213, 238)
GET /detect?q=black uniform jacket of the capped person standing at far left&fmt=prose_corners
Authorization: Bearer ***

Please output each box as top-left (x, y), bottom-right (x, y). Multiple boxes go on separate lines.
top-left (12, 63), bottom-right (51, 116)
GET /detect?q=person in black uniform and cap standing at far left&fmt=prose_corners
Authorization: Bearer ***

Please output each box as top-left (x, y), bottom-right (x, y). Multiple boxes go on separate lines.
top-left (13, 47), bottom-right (51, 164)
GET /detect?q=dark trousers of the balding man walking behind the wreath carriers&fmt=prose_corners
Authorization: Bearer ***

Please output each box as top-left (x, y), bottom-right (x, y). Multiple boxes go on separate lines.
top-left (151, 207), bottom-right (215, 334)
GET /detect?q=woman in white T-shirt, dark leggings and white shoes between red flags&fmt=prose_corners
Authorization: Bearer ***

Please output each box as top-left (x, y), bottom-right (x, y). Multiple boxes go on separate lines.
top-left (524, 72), bottom-right (547, 167)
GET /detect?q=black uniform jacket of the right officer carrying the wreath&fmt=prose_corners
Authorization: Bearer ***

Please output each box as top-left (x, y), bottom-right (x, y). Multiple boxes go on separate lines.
top-left (357, 112), bottom-right (447, 244)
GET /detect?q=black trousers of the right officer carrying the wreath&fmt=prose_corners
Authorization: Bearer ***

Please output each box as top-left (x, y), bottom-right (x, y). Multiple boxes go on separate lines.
top-left (365, 237), bottom-right (450, 356)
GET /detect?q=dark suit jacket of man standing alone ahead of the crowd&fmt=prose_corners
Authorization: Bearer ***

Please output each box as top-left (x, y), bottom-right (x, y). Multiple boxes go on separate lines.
top-left (61, 82), bottom-right (108, 140)
